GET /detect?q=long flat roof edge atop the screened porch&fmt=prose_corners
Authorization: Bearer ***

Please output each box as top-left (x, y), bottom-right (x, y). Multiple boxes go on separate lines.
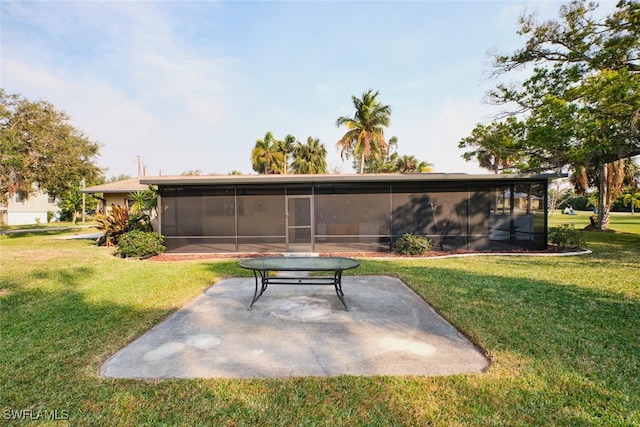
top-left (140, 173), bottom-right (567, 186)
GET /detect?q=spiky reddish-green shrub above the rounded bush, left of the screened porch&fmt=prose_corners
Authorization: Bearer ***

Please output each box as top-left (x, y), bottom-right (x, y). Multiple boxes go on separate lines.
top-left (96, 205), bottom-right (153, 246)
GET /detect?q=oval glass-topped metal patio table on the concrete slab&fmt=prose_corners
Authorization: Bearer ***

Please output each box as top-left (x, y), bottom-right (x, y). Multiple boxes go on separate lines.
top-left (240, 256), bottom-right (360, 310)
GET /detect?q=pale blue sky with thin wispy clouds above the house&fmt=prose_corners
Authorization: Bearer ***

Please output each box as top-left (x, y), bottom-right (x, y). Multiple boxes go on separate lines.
top-left (0, 0), bottom-right (614, 177)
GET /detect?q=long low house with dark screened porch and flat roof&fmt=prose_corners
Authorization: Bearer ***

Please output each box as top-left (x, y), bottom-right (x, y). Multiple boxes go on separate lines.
top-left (140, 173), bottom-right (561, 253)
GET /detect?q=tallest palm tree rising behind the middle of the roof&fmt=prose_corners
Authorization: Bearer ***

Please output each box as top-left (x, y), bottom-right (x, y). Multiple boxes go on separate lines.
top-left (336, 90), bottom-right (391, 173)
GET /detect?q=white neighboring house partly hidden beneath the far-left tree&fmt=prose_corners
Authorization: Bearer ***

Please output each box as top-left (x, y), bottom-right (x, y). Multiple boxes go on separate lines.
top-left (0, 191), bottom-right (60, 225)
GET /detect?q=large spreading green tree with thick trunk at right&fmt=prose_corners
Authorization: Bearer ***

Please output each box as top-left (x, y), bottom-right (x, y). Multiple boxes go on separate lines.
top-left (459, 0), bottom-right (640, 229)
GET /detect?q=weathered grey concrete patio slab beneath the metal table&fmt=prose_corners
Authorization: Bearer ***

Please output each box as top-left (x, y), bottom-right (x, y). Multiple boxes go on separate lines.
top-left (101, 276), bottom-right (489, 379)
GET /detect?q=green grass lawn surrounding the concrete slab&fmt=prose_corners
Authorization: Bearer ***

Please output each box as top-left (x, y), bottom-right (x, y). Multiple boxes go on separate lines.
top-left (0, 213), bottom-right (640, 426)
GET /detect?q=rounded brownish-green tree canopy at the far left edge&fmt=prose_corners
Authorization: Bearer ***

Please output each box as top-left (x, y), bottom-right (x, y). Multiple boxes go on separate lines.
top-left (0, 89), bottom-right (101, 201)
